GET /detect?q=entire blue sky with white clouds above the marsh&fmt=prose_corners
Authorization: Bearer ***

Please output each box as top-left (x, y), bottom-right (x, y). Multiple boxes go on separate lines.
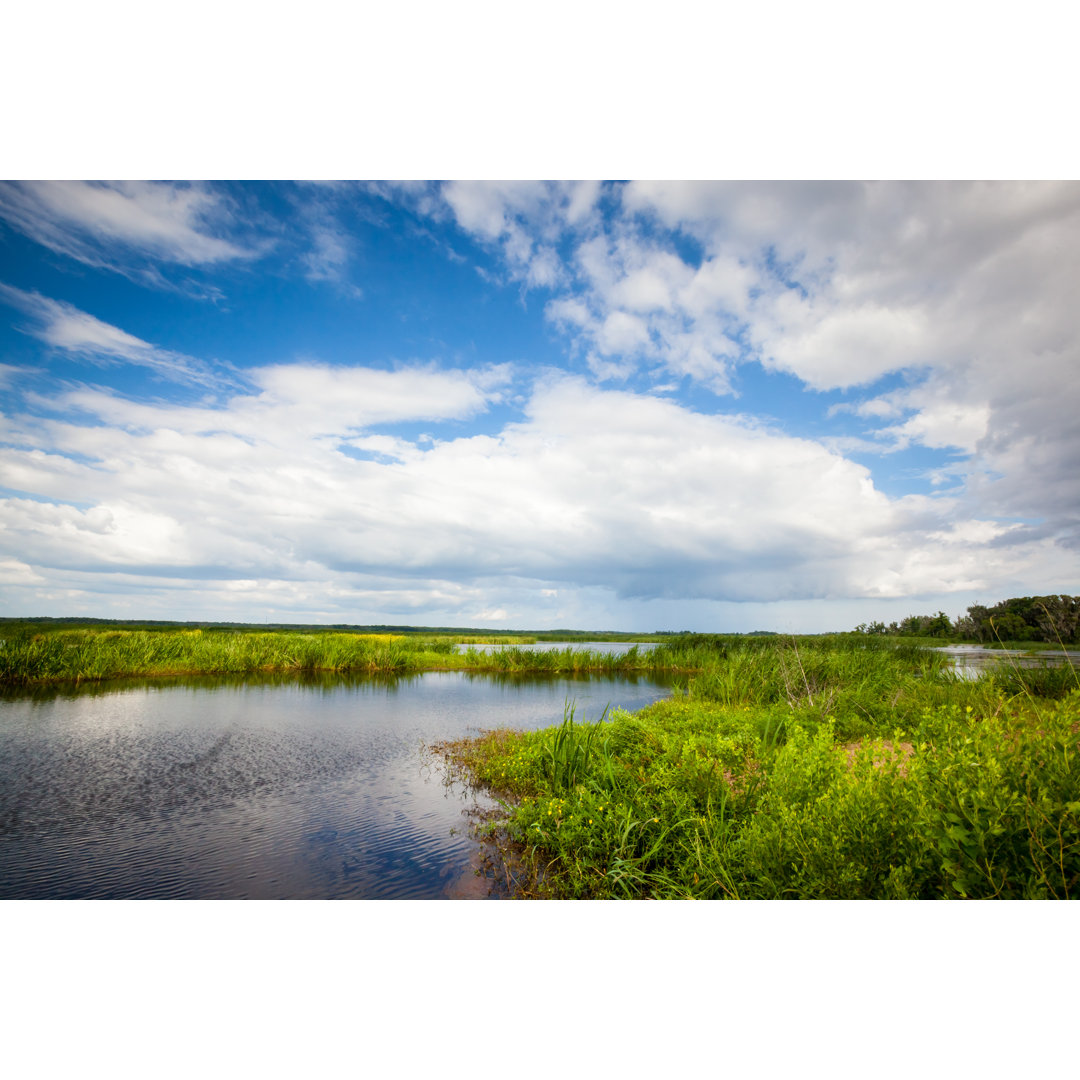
top-left (0, 181), bottom-right (1080, 632)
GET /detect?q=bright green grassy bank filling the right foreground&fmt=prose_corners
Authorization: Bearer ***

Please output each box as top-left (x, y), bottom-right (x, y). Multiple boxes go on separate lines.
top-left (441, 638), bottom-right (1080, 899)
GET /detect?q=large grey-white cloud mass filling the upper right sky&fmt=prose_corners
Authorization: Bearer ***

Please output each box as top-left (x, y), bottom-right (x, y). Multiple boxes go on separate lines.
top-left (425, 181), bottom-right (1080, 543)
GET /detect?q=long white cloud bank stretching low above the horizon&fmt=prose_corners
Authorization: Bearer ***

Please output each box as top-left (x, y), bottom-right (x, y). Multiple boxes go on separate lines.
top-left (6, 365), bottom-right (1075, 619)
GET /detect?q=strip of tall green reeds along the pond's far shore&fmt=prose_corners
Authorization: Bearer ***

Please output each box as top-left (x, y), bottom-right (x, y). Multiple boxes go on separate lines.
top-left (0, 620), bottom-right (1071, 686)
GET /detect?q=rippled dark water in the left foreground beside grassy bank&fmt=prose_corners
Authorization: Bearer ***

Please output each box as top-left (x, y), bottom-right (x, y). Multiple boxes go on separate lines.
top-left (0, 672), bottom-right (667, 899)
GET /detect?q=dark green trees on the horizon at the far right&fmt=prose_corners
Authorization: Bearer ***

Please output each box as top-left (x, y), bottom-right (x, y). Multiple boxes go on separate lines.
top-left (855, 595), bottom-right (1080, 644)
